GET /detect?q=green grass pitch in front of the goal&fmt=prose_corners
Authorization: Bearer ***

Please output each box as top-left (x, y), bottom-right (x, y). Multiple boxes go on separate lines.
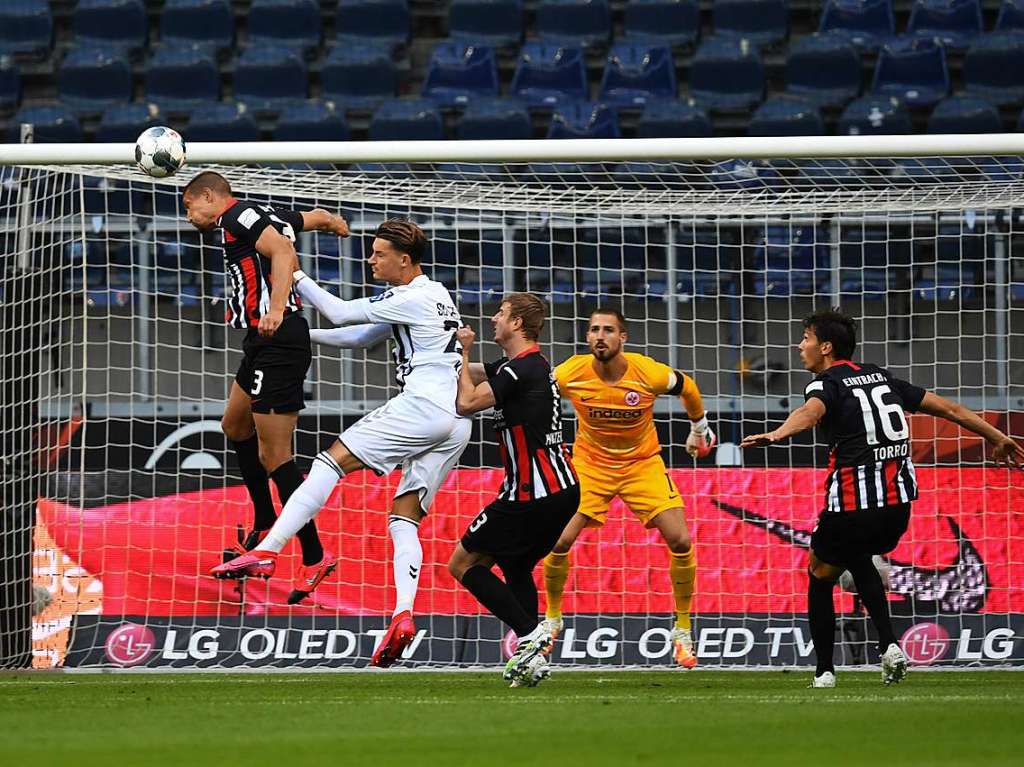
top-left (0, 670), bottom-right (1024, 767)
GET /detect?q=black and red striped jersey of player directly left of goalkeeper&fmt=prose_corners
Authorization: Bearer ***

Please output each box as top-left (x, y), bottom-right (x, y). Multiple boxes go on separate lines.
top-left (484, 345), bottom-right (579, 502)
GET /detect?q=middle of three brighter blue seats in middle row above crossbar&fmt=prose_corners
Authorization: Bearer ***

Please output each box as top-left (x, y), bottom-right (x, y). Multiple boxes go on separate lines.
top-left (511, 42), bottom-right (588, 106)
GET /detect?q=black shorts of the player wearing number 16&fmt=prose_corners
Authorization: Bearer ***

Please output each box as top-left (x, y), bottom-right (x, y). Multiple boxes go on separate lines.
top-left (811, 504), bottom-right (910, 565)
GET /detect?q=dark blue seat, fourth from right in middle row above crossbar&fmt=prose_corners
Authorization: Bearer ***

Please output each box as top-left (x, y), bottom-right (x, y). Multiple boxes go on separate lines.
top-left (690, 37), bottom-right (765, 112)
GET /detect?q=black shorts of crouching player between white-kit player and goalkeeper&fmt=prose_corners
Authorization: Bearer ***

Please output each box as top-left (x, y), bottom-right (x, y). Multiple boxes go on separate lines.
top-left (462, 484), bottom-right (580, 564)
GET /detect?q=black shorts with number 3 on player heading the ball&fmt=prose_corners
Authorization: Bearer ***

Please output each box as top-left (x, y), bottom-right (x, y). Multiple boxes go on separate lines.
top-left (234, 312), bottom-right (312, 413)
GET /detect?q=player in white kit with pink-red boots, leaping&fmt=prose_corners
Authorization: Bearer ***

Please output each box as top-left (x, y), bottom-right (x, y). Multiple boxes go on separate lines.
top-left (218, 219), bottom-right (471, 666)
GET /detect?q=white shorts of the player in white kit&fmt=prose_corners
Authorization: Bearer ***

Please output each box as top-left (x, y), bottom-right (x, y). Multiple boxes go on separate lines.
top-left (338, 392), bottom-right (472, 513)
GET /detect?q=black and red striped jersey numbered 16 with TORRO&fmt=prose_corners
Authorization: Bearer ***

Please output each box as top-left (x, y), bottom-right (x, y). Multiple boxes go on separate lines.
top-left (804, 359), bottom-right (925, 511)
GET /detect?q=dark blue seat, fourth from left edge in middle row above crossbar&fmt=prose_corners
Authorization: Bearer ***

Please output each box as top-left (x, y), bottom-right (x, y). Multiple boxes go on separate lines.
top-left (234, 45), bottom-right (309, 111)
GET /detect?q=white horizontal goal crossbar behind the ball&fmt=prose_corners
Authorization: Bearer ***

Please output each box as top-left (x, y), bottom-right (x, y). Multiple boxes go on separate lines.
top-left (8, 133), bottom-right (1024, 165)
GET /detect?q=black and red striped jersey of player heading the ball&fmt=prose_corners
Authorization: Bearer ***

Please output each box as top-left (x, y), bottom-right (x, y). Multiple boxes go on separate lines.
top-left (217, 200), bottom-right (302, 328)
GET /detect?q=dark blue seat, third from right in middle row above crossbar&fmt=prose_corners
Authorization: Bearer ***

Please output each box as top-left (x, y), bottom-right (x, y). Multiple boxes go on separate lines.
top-left (785, 34), bottom-right (861, 106)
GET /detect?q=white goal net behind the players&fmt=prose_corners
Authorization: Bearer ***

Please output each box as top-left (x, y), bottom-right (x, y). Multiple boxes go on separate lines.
top-left (0, 146), bottom-right (1024, 669)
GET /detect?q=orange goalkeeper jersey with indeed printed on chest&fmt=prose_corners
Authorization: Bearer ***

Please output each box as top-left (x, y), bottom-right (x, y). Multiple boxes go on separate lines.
top-left (555, 352), bottom-right (673, 468)
